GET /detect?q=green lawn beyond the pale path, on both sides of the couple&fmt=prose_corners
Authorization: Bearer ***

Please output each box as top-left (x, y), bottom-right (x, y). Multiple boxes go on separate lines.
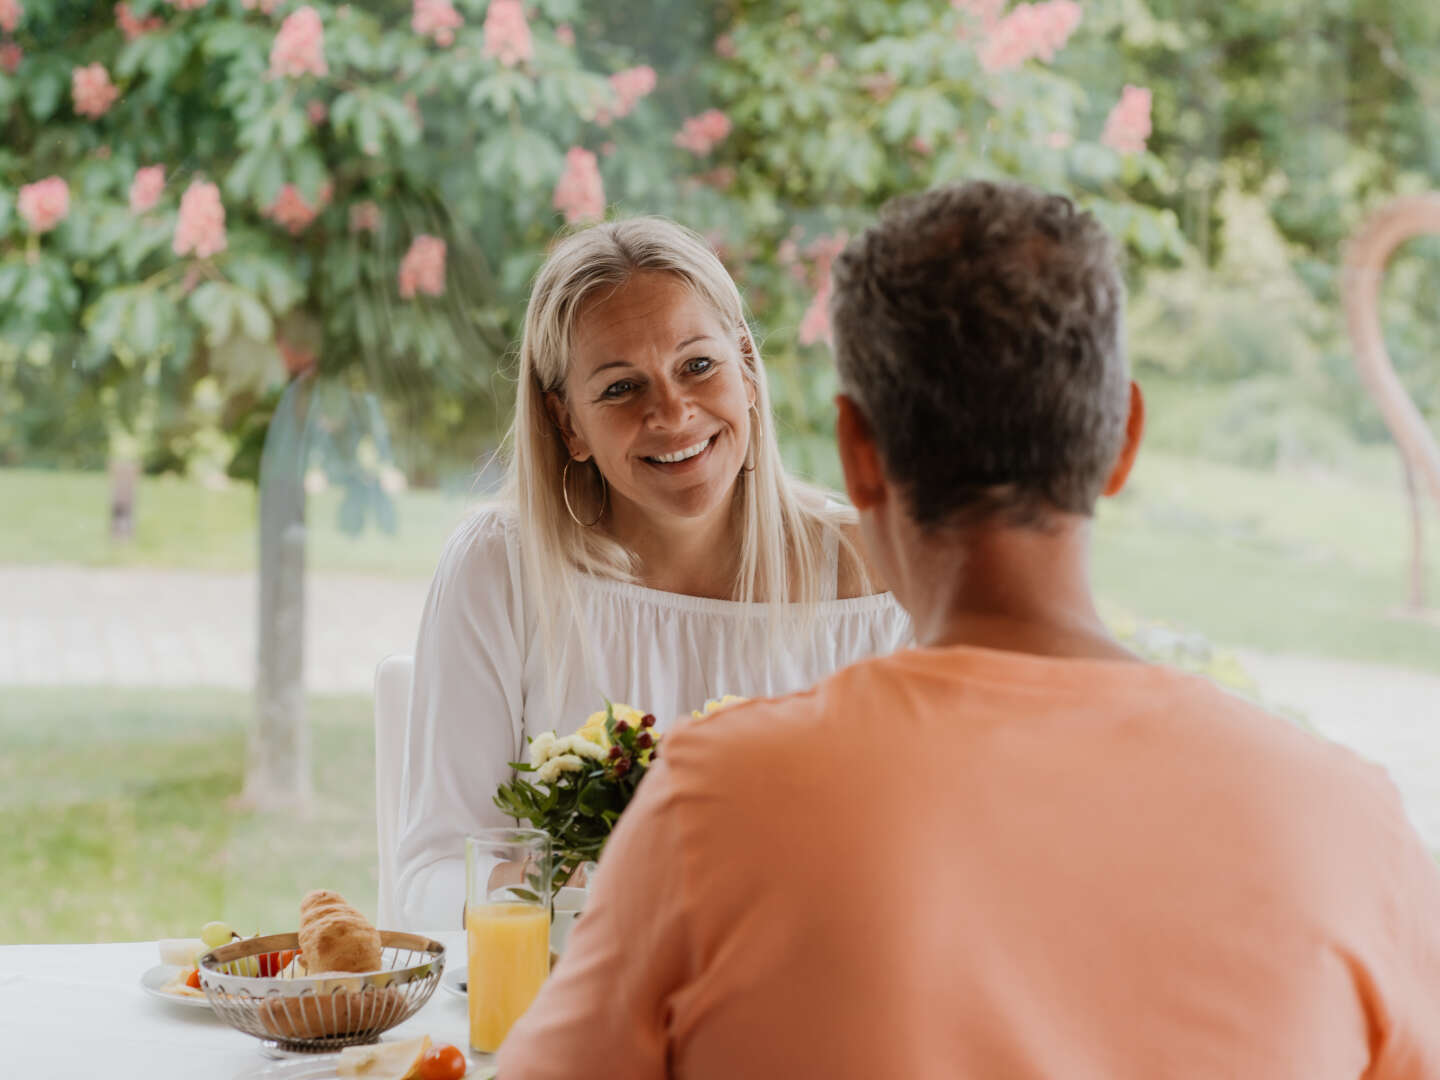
top-left (0, 451), bottom-right (1440, 671)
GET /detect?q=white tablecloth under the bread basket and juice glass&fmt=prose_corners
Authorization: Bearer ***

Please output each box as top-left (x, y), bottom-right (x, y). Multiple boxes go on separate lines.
top-left (0, 930), bottom-right (477, 1080)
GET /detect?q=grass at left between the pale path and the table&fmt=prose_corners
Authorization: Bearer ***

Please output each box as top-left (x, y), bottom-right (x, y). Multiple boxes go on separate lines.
top-left (0, 687), bottom-right (376, 945)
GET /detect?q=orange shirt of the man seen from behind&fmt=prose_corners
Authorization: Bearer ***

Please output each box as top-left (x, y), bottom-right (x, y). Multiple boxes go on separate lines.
top-left (500, 648), bottom-right (1440, 1080)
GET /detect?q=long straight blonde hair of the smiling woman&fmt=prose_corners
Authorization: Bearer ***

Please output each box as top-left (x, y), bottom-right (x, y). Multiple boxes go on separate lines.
top-left (507, 217), bottom-right (868, 668)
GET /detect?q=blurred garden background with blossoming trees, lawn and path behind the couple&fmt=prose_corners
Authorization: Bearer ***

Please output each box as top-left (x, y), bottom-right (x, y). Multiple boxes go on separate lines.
top-left (0, 0), bottom-right (1440, 943)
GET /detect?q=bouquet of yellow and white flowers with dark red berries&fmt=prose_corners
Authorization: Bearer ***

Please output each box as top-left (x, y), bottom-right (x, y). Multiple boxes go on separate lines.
top-left (495, 696), bottom-right (743, 896)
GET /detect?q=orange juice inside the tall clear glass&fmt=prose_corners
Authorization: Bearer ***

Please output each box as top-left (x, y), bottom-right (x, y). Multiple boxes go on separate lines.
top-left (465, 903), bottom-right (550, 1054)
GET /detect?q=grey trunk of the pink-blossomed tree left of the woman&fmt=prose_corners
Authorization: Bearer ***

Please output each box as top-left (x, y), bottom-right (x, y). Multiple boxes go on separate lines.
top-left (240, 379), bottom-right (314, 811)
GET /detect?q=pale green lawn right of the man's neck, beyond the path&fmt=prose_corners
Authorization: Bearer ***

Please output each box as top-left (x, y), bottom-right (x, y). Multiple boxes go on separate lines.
top-left (1094, 455), bottom-right (1440, 671)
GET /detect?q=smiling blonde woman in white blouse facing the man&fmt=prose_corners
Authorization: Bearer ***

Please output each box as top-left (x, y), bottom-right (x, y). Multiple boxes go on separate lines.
top-left (397, 217), bottom-right (912, 927)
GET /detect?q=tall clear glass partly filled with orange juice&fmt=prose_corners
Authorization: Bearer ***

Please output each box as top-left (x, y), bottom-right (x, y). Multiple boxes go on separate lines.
top-left (465, 828), bottom-right (550, 1054)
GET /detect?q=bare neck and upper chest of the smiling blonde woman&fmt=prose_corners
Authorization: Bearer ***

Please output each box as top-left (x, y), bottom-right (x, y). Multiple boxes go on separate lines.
top-left (611, 492), bottom-right (739, 600)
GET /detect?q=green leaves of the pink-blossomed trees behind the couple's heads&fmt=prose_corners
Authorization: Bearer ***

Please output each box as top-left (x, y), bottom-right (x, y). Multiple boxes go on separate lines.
top-left (0, 0), bottom-right (1184, 489)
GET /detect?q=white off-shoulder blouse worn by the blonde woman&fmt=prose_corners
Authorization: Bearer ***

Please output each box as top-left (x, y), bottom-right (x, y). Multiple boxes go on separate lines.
top-left (396, 507), bottom-right (912, 930)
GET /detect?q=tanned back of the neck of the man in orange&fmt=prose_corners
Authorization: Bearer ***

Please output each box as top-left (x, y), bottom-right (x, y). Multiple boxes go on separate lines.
top-left (901, 516), bottom-right (1135, 660)
